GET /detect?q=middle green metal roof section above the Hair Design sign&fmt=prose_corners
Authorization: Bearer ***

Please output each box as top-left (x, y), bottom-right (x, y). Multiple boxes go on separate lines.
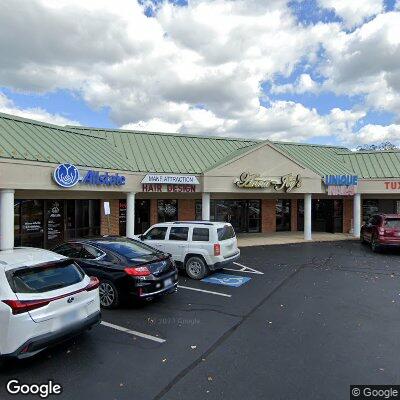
top-left (68, 126), bottom-right (257, 174)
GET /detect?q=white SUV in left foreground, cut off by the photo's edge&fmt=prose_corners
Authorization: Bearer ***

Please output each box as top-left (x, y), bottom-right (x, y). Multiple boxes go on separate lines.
top-left (0, 247), bottom-right (100, 362)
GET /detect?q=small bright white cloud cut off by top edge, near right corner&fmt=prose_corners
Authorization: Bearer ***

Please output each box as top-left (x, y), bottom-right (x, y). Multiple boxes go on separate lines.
top-left (318, 0), bottom-right (384, 28)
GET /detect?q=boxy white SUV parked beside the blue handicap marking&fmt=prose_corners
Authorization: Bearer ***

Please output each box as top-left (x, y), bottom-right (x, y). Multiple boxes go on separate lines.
top-left (137, 221), bottom-right (240, 279)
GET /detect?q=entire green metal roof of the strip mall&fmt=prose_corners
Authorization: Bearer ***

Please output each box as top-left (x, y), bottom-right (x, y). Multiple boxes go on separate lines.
top-left (0, 113), bottom-right (400, 178)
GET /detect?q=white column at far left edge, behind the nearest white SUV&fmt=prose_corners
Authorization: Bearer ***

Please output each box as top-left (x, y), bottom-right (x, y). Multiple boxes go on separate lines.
top-left (0, 189), bottom-right (14, 250)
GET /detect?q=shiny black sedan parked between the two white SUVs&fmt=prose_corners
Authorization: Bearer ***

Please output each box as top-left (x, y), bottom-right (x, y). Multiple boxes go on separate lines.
top-left (53, 237), bottom-right (178, 308)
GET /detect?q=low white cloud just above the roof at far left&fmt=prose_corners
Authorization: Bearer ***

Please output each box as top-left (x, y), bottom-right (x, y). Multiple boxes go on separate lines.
top-left (0, 93), bottom-right (80, 125)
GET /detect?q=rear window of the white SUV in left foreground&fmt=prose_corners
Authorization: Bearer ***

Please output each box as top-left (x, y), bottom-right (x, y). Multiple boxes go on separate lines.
top-left (8, 260), bottom-right (85, 293)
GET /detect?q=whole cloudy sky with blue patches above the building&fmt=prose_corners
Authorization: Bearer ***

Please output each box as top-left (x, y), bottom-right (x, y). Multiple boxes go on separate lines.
top-left (0, 0), bottom-right (400, 147)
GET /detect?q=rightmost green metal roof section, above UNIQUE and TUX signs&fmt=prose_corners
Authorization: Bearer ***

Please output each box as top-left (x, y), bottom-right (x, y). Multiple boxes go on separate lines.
top-left (341, 150), bottom-right (400, 179)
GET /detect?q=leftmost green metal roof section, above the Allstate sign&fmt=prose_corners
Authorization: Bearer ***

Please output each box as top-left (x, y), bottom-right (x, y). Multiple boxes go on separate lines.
top-left (0, 113), bottom-right (130, 170)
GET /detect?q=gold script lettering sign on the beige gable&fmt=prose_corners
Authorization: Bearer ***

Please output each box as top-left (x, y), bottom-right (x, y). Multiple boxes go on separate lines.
top-left (234, 172), bottom-right (302, 192)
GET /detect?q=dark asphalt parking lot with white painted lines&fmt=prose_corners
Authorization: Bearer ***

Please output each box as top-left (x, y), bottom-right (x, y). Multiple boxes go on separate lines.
top-left (0, 241), bottom-right (400, 400)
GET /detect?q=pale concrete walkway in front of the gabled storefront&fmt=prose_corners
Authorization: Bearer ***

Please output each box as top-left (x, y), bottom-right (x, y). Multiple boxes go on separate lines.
top-left (238, 232), bottom-right (356, 247)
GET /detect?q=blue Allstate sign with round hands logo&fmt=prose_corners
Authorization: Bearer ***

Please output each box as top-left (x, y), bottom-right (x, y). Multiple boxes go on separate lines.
top-left (53, 164), bottom-right (125, 188)
